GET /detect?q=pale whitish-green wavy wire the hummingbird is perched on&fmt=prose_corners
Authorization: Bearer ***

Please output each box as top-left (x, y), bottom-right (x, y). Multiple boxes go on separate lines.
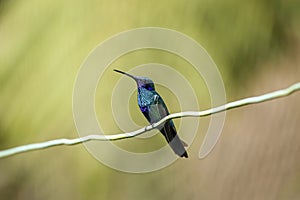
top-left (0, 82), bottom-right (300, 158)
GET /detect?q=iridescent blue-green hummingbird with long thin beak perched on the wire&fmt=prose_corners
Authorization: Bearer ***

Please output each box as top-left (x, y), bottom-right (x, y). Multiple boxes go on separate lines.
top-left (114, 69), bottom-right (188, 158)
